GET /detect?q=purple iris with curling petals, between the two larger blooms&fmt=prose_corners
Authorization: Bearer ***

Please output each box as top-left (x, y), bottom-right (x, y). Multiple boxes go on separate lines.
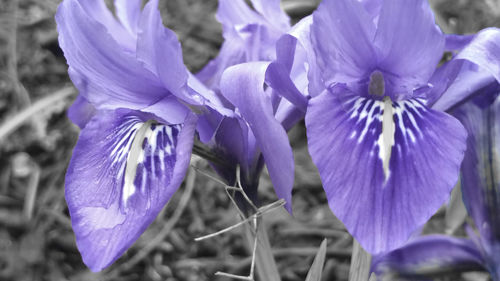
top-left (197, 0), bottom-right (307, 211)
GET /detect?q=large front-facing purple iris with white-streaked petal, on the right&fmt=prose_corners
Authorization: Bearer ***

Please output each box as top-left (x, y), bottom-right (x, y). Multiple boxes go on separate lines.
top-left (299, 0), bottom-right (499, 254)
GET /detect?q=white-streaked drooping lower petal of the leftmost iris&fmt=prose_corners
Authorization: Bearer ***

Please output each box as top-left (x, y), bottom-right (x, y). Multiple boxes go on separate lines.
top-left (65, 109), bottom-right (196, 271)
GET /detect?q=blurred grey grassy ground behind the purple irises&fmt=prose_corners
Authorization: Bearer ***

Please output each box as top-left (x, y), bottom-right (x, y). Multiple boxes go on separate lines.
top-left (0, 0), bottom-right (500, 281)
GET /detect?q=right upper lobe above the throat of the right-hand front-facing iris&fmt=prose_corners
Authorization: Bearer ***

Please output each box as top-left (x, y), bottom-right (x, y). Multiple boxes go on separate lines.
top-left (375, 0), bottom-right (445, 93)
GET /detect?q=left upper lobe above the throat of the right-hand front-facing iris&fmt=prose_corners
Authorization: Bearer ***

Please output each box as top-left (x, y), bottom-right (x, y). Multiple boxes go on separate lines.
top-left (310, 0), bottom-right (376, 85)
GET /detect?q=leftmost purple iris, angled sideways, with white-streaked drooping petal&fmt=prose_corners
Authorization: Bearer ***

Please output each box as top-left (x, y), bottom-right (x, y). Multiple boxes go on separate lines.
top-left (56, 0), bottom-right (224, 271)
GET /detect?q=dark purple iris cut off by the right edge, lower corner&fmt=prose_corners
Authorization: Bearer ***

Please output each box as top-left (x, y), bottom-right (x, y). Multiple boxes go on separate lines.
top-left (372, 85), bottom-right (500, 281)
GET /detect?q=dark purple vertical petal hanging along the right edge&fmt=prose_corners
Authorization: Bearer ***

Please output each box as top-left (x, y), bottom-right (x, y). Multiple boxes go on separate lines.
top-left (453, 97), bottom-right (500, 245)
